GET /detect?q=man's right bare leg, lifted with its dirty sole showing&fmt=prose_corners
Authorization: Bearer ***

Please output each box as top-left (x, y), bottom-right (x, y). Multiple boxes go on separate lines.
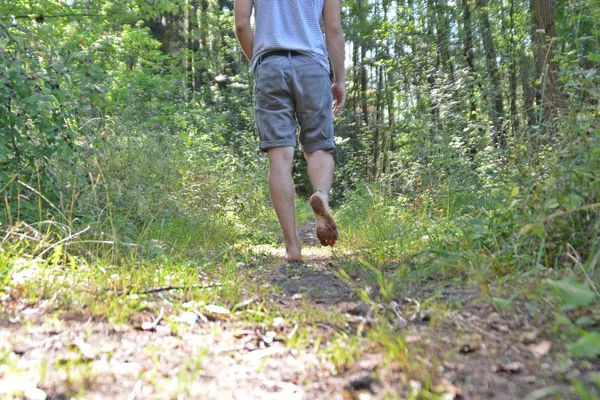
top-left (304, 150), bottom-right (338, 246)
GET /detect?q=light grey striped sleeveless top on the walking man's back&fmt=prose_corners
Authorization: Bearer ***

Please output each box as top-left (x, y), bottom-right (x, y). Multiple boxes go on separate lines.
top-left (252, 0), bottom-right (329, 72)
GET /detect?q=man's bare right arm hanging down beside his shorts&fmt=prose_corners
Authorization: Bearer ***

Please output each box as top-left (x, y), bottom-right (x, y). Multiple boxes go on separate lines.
top-left (323, 0), bottom-right (346, 115)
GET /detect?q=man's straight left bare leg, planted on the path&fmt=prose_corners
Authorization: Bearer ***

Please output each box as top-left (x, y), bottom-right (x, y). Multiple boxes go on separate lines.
top-left (269, 147), bottom-right (301, 261)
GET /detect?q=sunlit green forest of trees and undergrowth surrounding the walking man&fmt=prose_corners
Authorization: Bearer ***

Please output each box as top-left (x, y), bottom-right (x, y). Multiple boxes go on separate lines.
top-left (0, 0), bottom-right (600, 398)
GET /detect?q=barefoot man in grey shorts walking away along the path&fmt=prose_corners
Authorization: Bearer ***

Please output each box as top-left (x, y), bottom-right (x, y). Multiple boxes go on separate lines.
top-left (235, 0), bottom-right (346, 261)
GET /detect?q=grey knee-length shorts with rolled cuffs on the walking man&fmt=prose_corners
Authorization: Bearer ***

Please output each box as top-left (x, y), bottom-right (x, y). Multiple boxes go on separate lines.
top-left (254, 54), bottom-right (335, 153)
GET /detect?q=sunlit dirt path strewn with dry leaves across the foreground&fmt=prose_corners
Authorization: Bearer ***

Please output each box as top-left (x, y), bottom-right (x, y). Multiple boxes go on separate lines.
top-left (0, 223), bottom-right (600, 400)
